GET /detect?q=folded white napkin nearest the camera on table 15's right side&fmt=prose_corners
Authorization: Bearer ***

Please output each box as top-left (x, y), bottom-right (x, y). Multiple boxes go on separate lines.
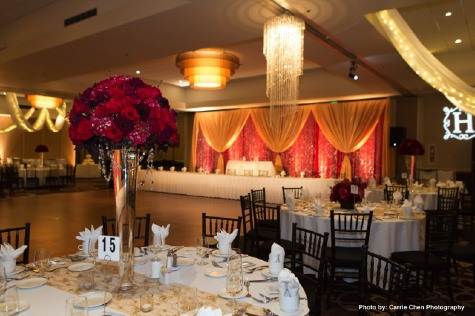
top-left (277, 269), bottom-right (300, 312)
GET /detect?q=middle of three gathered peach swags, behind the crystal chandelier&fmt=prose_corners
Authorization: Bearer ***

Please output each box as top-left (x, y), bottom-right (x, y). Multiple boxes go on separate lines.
top-left (251, 107), bottom-right (310, 172)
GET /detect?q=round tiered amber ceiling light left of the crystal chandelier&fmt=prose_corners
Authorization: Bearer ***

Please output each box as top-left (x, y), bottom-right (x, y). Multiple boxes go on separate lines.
top-left (176, 48), bottom-right (239, 90)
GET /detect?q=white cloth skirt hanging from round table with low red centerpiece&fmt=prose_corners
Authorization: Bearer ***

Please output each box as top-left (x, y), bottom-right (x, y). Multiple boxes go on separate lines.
top-left (280, 210), bottom-right (424, 257)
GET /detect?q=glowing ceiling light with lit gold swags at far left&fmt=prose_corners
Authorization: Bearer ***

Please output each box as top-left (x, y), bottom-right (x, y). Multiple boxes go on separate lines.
top-left (0, 92), bottom-right (66, 133)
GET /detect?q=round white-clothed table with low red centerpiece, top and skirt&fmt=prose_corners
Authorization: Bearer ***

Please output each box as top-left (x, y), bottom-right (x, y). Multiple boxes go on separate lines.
top-left (280, 200), bottom-right (425, 257)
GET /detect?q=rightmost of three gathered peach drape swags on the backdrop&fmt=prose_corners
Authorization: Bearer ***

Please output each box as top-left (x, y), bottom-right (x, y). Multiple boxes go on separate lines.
top-left (312, 99), bottom-right (389, 179)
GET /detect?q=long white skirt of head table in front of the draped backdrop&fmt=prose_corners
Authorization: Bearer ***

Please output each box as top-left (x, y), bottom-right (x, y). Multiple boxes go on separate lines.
top-left (137, 170), bottom-right (338, 203)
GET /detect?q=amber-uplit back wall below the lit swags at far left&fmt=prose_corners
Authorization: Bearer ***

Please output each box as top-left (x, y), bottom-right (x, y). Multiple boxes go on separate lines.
top-left (0, 116), bottom-right (75, 164)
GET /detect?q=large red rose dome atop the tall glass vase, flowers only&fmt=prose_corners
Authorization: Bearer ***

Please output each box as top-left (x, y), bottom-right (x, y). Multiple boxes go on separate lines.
top-left (69, 76), bottom-right (178, 148)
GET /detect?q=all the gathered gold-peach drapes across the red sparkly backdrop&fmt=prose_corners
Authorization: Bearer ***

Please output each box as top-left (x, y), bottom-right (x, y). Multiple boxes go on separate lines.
top-left (191, 99), bottom-right (390, 179)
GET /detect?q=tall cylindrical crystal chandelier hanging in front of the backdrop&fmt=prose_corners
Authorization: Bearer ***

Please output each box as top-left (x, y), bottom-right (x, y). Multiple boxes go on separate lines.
top-left (263, 14), bottom-right (305, 112)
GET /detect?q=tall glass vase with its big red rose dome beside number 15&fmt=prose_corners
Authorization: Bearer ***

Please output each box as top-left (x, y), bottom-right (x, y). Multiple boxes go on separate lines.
top-left (69, 76), bottom-right (178, 291)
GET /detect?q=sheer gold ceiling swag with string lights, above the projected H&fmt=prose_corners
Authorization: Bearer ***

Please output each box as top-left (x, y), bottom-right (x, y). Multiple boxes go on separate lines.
top-left (375, 9), bottom-right (475, 115)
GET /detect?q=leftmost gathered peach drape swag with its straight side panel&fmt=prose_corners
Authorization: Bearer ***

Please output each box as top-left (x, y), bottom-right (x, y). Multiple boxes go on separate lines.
top-left (192, 110), bottom-right (249, 172)
